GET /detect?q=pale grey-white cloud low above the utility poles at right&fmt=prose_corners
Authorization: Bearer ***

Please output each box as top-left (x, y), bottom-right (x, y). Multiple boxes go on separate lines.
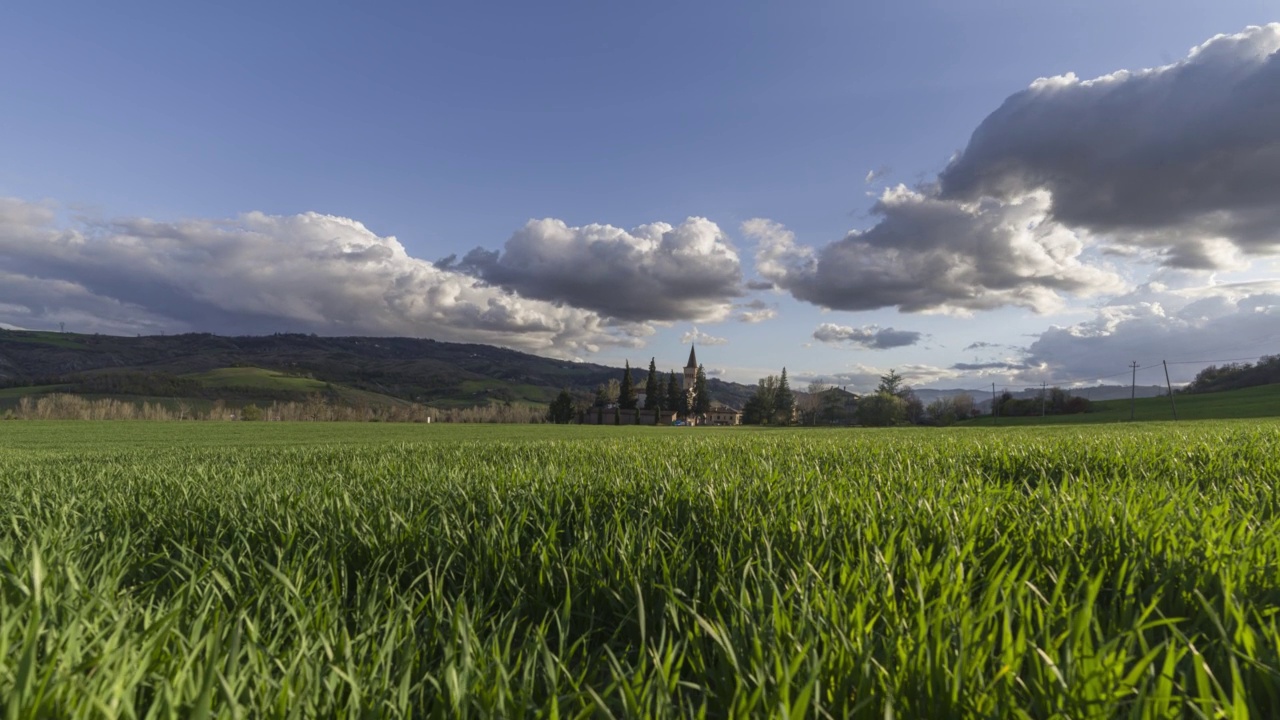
top-left (1027, 281), bottom-right (1280, 383)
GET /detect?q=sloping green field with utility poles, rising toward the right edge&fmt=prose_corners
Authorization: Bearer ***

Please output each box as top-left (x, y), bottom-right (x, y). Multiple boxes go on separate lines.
top-left (965, 384), bottom-right (1280, 425)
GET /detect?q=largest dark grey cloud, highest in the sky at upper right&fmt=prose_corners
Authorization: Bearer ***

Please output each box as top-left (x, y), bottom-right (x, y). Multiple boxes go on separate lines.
top-left (940, 23), bottom-right (1280, 269)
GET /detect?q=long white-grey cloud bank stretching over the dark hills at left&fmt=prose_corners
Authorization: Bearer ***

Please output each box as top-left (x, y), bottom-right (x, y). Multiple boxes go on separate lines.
top-left (0, 199), bottom-right (640, 356)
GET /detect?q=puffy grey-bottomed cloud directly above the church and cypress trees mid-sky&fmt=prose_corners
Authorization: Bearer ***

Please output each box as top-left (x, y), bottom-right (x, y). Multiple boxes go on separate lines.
top-left (447, 212), bottom-right (742, 322)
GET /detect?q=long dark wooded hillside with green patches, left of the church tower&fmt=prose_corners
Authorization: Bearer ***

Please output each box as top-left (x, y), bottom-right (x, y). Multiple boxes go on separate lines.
top-left (0, 329), bottom-right (751, 407)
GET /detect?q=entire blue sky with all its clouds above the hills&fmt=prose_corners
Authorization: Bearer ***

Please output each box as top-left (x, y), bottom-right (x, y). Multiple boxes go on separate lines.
top-left (0, 0), bottom-right (1280, 391)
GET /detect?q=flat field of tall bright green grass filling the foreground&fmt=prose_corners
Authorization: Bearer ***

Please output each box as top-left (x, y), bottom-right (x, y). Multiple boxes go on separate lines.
top-left (0, 421), bottom-right (1280, 719)
